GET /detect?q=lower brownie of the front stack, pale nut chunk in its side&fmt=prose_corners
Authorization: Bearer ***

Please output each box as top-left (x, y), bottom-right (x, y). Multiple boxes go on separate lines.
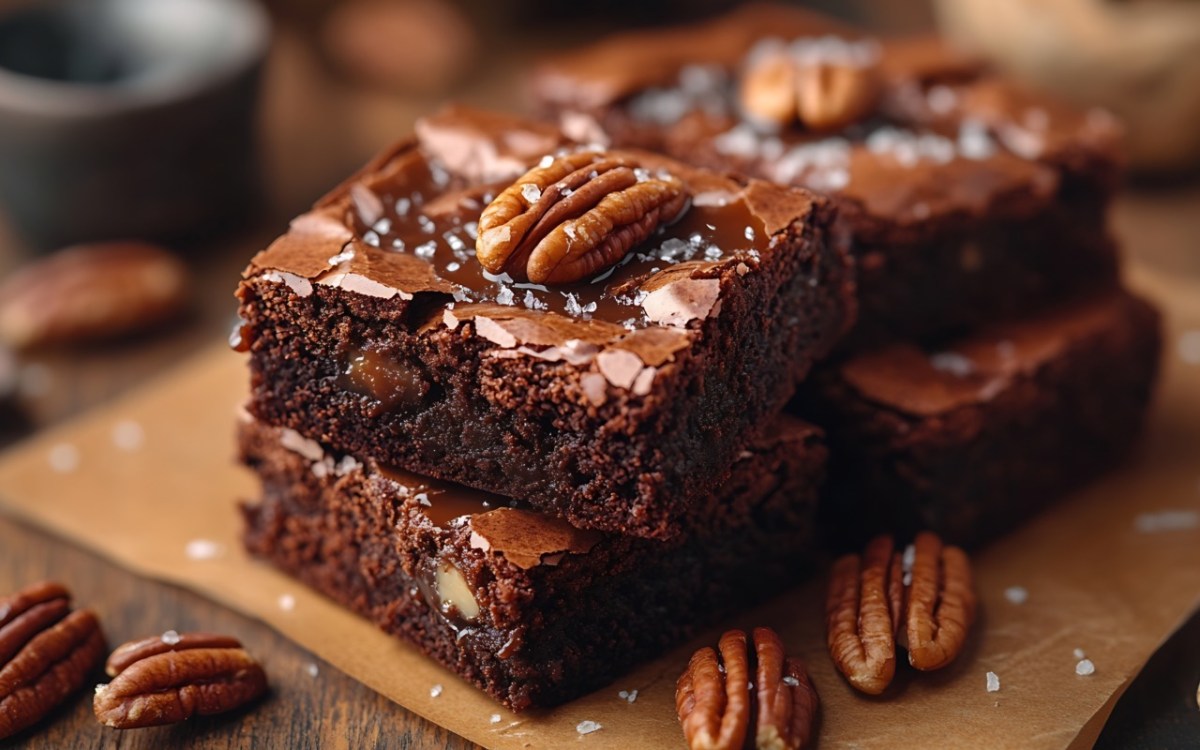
top-left (240, 418), bottom-right (826, 710)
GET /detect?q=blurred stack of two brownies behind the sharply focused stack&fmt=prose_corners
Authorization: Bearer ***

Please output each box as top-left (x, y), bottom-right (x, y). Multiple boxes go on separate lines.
top-left (533, 5), bottom-right (1159, 545)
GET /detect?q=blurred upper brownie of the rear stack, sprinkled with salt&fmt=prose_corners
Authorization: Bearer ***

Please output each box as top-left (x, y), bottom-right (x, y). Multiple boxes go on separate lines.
top-left (532, 5), bottom-right (1120, 348)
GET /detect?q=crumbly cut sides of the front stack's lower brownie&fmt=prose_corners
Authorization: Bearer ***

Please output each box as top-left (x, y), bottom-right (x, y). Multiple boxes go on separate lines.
top-left (240, 426), bottom-right (824, 710)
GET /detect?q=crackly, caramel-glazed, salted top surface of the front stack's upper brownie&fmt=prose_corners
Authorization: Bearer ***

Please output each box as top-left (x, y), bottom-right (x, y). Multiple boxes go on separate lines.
top-left (246, 108), bottom-right (821, 386)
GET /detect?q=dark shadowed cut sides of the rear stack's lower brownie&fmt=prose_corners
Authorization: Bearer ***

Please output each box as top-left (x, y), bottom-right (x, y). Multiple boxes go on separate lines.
top-left (792, 295), bottom-right (1160, 546)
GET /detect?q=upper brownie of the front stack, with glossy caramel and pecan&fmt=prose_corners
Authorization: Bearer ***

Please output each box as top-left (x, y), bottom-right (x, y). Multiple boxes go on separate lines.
top-left (238, 109), bottom-right (854, 539)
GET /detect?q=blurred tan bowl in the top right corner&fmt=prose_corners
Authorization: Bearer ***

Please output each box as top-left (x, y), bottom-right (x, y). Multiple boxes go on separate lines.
top-left (936, 0), bottom-right (1200, 173)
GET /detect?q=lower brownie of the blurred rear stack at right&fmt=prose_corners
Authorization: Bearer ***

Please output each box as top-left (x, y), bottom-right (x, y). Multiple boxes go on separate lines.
top-left (793, 292), bottom-right (1160, 545)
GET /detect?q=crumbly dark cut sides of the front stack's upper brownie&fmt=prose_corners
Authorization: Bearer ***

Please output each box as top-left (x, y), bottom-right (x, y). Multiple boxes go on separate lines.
top-left (240, 204), bottom-right (854, 539)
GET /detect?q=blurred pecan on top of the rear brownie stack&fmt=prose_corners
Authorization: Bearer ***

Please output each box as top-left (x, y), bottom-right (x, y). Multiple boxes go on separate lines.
top-left (739, 45), bottom-right (882, 131)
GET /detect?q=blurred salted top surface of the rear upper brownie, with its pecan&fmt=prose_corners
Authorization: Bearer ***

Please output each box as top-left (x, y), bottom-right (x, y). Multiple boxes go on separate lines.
top-left (534, 5), bottom-right (1120, 223)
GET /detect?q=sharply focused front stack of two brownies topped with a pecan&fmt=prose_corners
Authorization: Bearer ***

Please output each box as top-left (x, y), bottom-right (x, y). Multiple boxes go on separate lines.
top-left (236, 109), bottom-right (854, 709)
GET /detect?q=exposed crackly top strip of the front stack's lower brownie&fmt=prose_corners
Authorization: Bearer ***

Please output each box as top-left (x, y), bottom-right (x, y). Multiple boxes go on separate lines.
top-left (267, 414), bottom-right (821, 570)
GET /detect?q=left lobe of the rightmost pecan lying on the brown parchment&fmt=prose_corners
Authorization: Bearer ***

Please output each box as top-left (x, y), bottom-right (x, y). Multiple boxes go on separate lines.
top-left (826, 536), bottom-right (904, 695)
